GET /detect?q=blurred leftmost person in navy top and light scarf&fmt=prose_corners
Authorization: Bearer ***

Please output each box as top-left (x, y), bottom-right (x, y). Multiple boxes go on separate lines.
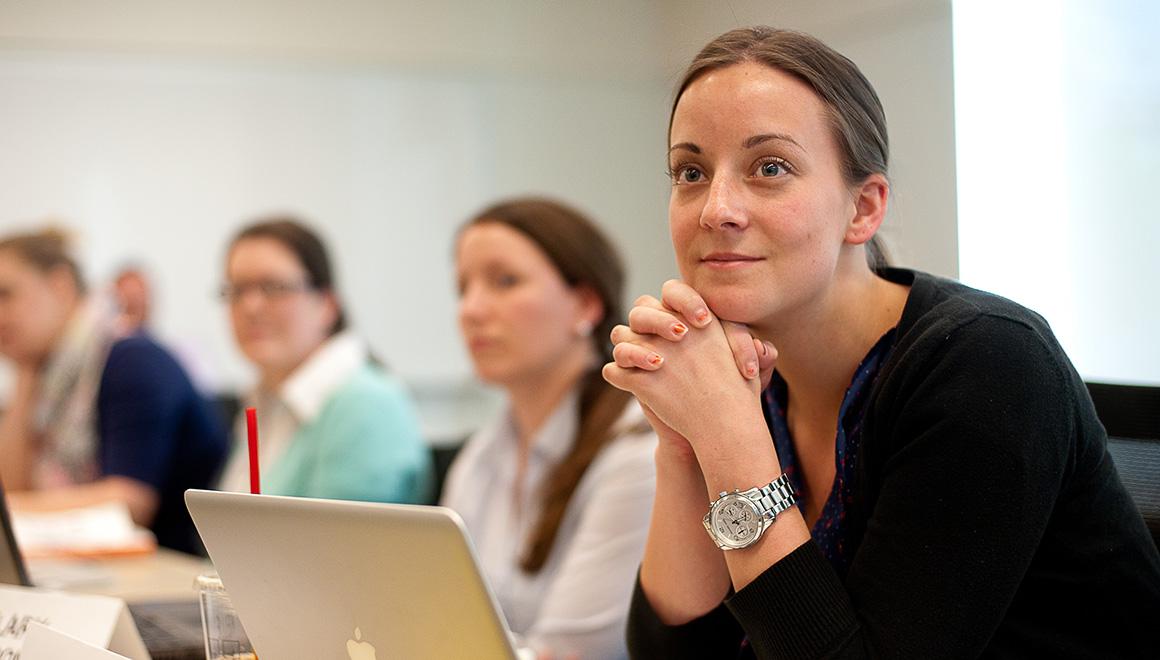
top-left (0, 226), bottom-right (226, 551)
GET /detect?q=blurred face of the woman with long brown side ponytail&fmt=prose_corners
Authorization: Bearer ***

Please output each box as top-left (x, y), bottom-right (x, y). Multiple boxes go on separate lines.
top-left (456, 222), bottom-right (599, 386)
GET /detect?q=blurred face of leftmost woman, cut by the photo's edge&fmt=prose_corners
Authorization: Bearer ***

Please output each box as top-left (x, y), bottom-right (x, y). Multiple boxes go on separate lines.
top-left (0, 251), bottom-right (77, 363)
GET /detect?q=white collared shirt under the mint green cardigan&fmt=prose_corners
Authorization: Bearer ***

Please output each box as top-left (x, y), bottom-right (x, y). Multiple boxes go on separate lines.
top-left (218, 331), bottom-right (369, 492)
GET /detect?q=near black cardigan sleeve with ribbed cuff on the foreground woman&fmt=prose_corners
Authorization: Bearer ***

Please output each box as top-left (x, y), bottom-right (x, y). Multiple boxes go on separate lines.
top-left (728, 314), bottom-right (1075, 658)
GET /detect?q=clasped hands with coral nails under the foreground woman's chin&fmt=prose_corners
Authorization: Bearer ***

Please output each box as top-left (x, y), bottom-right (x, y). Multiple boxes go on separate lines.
top-left (603, 280), bottom-right (777, 450)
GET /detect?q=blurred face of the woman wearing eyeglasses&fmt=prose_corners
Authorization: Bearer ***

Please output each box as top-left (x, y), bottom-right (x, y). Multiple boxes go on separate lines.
top-left (226, 238), bottom-right (338, 378)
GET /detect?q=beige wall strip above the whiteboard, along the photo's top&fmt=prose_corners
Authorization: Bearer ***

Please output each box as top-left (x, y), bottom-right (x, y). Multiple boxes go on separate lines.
top-left (0, 0), bottom-right (668, 80)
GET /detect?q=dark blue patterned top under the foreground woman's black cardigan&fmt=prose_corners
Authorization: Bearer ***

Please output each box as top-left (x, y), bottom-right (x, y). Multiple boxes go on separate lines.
top-left (761, 329), bottom-right (894, 578)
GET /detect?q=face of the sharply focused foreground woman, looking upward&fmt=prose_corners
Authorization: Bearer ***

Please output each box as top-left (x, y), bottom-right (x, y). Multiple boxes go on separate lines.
top-left (669, 63), bottom-right (855, 324)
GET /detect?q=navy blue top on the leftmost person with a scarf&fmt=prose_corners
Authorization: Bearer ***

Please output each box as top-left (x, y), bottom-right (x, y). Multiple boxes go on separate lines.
top-left (96, 334), bottom-right (227, 552)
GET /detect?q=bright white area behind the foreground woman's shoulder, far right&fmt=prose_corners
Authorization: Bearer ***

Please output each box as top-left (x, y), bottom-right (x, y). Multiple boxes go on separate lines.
top-left (955, 0), bottom-right (1160, 384)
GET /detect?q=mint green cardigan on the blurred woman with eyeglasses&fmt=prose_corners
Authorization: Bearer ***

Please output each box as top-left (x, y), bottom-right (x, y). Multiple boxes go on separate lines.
top-left (262, 364), bottom-right (432, 503)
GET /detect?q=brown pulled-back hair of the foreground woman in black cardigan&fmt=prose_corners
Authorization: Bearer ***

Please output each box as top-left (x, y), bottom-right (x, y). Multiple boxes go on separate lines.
top-left (668, 26), bottom-right (890, 270)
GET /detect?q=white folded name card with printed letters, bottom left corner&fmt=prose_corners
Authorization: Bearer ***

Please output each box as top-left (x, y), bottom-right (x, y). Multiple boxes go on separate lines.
top-left (0, 586), bottom-right (148, 660)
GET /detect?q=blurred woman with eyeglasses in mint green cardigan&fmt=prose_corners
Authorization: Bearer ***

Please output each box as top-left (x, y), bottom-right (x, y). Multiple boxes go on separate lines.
top-left (220, 218), bottom-right (430, 503)
